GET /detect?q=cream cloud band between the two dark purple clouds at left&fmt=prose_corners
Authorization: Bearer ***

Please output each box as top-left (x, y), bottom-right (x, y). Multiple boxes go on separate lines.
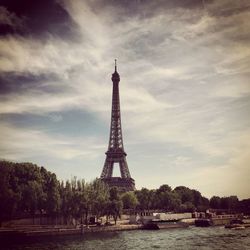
top-left (0, 36), bottom-right (86, 77)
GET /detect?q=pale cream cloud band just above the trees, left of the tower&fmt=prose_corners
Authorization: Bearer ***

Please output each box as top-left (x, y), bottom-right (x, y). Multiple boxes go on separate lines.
top-left (0, 123), bottom-right (104, 161)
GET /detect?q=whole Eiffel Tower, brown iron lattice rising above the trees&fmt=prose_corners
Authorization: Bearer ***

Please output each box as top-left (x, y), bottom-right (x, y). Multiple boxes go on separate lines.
top-left (101, 60), bottom-right (135, 191)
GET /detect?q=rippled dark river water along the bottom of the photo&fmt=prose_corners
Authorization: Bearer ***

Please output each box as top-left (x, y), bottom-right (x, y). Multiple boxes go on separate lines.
top-left (0, 227), bottom-right (250, 250)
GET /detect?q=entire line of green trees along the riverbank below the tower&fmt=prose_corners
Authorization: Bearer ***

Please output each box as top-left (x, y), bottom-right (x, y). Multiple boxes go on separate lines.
top-left (0, 161), bottom-right (250, 224)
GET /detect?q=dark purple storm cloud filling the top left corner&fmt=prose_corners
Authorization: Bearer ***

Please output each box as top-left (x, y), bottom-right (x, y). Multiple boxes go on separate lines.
top-left (0, 0), bottom-right (78, 39)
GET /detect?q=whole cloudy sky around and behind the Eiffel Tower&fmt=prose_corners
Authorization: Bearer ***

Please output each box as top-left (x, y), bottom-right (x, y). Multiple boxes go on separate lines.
top-left (0, 0), bottom-right (250, 199)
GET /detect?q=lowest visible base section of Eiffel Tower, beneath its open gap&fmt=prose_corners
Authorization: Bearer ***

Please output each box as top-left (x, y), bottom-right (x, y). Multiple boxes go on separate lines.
top-left (101, 177), bottom-right (135, 192)
